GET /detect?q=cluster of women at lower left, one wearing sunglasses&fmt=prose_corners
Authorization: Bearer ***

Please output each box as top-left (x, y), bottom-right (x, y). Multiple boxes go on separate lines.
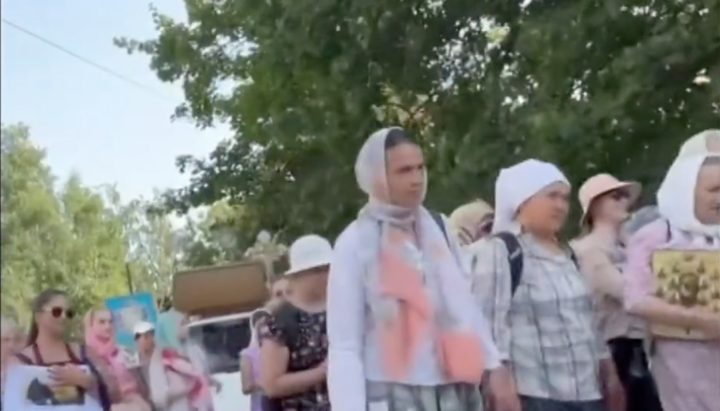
top-left (0, 289), bottom-right (220, 411)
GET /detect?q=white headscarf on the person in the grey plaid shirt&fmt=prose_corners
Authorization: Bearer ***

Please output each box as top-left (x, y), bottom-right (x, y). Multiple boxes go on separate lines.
top-left (492, 159), bottom-right (570, 233)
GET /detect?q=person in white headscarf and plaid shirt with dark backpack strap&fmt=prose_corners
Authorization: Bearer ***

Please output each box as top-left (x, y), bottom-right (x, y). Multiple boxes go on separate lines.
top-left (472, 160), bottom-right (624, 411)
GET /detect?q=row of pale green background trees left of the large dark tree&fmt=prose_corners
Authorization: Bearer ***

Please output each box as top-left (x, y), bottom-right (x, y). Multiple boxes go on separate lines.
top-left (0, 124), bottom-right (240, 322)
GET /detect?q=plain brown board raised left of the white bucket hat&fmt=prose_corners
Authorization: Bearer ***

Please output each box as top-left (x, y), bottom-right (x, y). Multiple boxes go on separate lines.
top-left (173, 261), bottom-right (269, 317)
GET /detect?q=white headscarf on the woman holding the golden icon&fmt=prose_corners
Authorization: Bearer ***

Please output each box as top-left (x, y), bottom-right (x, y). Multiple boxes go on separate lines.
top-left (657, 153), bottom-right (720, 237)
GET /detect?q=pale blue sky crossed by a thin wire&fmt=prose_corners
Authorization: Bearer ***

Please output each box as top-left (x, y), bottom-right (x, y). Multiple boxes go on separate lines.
top-left (0, 0), bottom-right (230, 200)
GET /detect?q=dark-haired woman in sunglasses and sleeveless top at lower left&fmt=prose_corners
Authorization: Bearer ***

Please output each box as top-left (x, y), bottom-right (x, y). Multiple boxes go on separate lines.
top-left (8, 289), bottom-right (119, 411)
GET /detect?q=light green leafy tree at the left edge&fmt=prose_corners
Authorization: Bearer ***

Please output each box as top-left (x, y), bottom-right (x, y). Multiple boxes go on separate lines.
top-left (1, 125), bottom-right (126, 320)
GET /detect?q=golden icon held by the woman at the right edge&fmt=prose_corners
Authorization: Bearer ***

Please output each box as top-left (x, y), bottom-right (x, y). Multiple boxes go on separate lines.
top-left (650, 250), bottom-right (720, 340)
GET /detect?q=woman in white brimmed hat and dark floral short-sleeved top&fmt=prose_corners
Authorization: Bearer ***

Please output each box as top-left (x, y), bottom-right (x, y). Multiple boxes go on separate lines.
top-left (258, 235), bottom-right (332, 411)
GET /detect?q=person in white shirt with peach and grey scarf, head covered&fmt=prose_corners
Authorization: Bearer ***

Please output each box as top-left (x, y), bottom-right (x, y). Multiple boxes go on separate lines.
top-left (328, 128), bottom-right (520, 411)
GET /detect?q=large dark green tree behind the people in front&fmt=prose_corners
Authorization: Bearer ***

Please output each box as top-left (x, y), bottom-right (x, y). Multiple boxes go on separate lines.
top-left (116, 0), bottom-right (720, 241)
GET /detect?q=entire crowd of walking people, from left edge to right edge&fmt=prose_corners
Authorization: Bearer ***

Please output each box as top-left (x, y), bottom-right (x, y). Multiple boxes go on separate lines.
top-left (2, 128), bottom-right (720, 411)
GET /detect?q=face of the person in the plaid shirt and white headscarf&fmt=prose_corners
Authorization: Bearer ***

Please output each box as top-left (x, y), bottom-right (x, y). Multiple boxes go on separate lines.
top-left (519, 182), bottom-right (570, 233)
